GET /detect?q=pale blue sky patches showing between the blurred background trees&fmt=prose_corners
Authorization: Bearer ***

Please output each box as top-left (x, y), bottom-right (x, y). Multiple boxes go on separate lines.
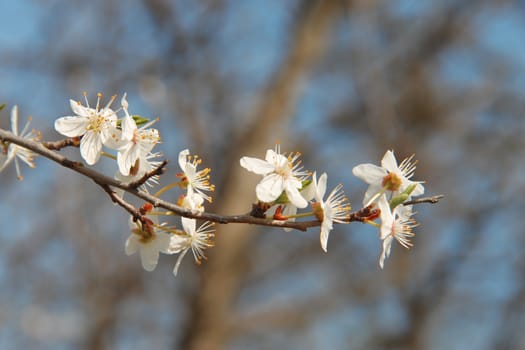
top-left (0, 0), bottom-right (525, 349)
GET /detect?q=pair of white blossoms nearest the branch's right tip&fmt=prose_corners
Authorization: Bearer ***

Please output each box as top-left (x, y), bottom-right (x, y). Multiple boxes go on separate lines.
top-left (352, 151), bottom-right (425, 268)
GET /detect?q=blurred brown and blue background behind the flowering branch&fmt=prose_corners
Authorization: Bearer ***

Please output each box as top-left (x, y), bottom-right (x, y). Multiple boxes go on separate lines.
top-left (0, 0), bottom-right (525, 350)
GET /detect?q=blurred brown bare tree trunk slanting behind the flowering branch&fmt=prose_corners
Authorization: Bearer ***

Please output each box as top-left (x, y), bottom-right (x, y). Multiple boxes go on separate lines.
top-left (183, 0), bottom-right (342, 350)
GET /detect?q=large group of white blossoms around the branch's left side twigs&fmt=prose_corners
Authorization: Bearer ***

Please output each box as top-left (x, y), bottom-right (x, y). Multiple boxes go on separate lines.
top-left (55, 94), bottom-right (214, 275)
